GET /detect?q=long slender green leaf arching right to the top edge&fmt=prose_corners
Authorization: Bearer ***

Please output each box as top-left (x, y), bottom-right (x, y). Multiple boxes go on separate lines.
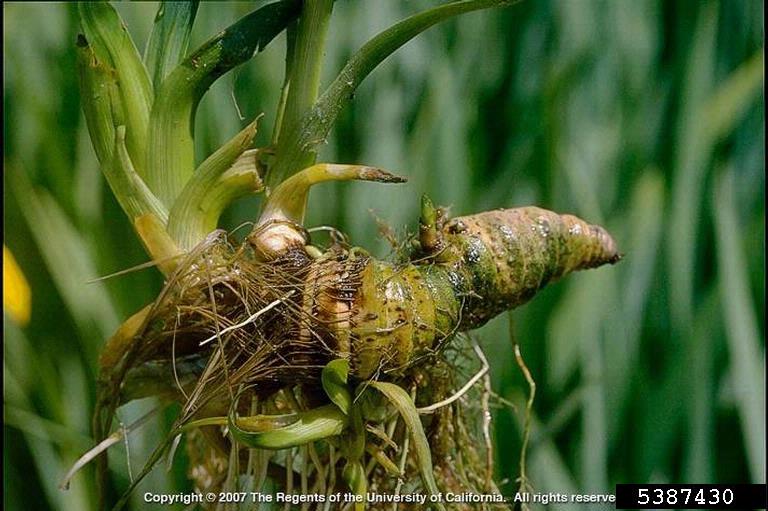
top-left (267, 0), bottom-right (516, 187)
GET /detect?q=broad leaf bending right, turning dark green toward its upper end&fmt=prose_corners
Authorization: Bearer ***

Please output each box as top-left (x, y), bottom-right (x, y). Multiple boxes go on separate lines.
top-left (147, 0), bottom-right (299, 207)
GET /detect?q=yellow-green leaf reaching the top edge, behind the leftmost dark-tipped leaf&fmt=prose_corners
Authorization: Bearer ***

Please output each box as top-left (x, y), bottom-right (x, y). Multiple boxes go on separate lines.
top-left (78, 2), bottom-right (152, 177)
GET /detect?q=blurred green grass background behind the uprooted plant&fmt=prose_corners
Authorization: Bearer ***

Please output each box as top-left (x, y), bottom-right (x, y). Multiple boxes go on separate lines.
top-left (3, 0), bottom-right (765, 511)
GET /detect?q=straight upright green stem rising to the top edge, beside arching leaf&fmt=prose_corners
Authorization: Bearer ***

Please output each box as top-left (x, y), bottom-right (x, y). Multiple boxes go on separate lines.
top-left (267, 0), bottom-right (333, 189)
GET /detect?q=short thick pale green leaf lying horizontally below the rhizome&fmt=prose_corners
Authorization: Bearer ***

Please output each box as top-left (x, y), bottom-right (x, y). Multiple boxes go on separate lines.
top-left (227, 406), bottom-right (348, 449)
